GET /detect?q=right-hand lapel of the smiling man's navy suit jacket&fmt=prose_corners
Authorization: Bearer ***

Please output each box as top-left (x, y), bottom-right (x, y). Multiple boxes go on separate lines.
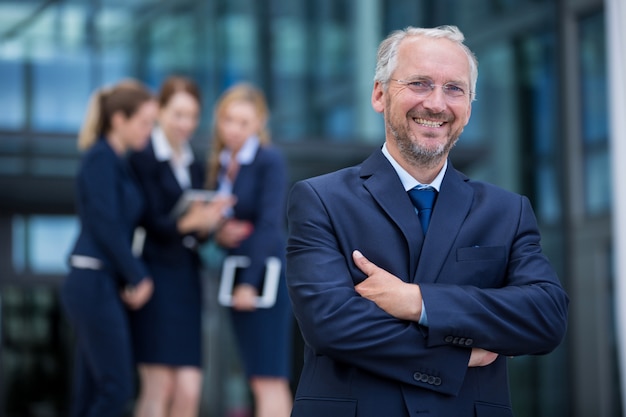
top-left (414, 167), bottom-right (474, 282)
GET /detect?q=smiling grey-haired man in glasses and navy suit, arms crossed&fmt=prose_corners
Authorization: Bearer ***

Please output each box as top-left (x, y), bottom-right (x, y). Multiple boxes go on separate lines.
top-left (287, 26), bottom-right (568, 417)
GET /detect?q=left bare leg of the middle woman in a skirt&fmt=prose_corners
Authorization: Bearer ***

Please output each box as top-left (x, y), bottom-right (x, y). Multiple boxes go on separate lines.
top-left (135, 364), bottom-right (175, 417)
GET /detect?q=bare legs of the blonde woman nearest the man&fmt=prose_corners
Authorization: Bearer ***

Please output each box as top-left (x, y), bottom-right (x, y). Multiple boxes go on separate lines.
top-left (250, 376), bottom-right (293, 417)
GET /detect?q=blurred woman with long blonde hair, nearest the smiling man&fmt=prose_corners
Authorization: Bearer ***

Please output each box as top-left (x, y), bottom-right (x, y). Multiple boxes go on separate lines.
top-left (207, 84), bottom-right (292, 417)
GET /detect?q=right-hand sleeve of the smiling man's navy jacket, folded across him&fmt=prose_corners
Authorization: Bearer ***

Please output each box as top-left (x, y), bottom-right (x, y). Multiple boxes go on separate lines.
top-left (420, 196), bottom-right (568, 356)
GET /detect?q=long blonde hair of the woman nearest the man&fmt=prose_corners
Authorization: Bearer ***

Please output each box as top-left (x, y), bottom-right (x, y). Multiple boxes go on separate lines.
top-left (206, 83), bottom-right (271, 189)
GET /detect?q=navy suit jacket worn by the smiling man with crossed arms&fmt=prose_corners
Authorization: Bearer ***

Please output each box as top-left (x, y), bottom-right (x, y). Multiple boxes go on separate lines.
top-left (287, 150), bottom-right (568, 417)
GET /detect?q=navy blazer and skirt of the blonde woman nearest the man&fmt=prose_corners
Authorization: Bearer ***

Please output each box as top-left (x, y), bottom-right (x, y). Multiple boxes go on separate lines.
top-left (219, 146), bottom-right (293, 378)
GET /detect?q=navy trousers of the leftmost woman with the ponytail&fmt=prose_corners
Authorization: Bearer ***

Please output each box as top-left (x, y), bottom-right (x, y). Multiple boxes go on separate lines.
top-left (63, 270), bottom-right (134, 417)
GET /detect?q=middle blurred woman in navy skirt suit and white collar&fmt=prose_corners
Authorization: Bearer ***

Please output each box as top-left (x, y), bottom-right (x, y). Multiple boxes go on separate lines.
top-left (130, 77), bottom-right (232, 417)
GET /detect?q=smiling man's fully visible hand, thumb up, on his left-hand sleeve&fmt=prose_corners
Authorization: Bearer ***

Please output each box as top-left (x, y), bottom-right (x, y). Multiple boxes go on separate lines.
top-left (352, 250), bottom-right (422, 322)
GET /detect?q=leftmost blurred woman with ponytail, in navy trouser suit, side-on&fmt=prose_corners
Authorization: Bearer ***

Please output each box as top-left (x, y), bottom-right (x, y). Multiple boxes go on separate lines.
top-left (61, 81), bottom-right (157, 417)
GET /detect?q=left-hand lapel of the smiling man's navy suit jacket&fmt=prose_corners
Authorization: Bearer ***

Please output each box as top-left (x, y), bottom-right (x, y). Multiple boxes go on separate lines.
top-left (361, 151), bottom-right (424, 279)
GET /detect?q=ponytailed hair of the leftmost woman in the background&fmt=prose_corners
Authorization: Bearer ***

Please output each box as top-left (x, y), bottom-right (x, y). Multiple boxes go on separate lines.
top-left (78, 79), bottom-right (154, 151)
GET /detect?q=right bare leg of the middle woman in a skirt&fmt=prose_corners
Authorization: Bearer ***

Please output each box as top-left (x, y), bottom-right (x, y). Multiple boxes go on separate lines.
top-left (169, 366), bottom-right (202, 417)
